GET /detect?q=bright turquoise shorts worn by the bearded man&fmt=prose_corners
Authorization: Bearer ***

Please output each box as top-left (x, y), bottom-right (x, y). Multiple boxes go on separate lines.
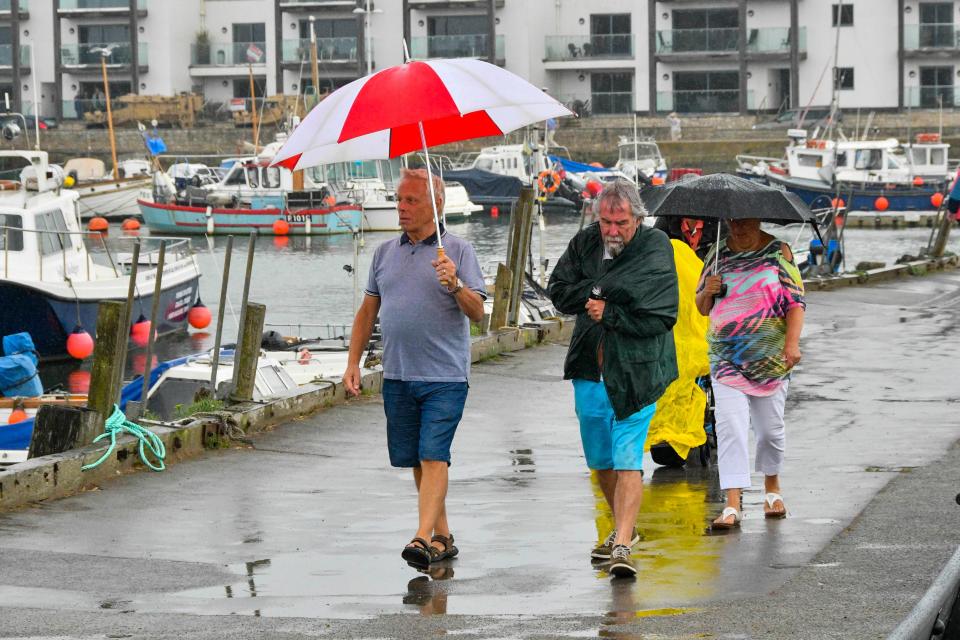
top-left (573, 380), bottom-right (657, 471)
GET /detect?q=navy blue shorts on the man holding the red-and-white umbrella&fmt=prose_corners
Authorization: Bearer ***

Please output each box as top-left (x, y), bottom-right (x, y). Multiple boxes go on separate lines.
top-left (382, 379), bottom-right (467, 467)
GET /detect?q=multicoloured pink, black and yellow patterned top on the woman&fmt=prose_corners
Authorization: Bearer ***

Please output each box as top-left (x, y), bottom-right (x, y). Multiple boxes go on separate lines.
top-left (700, 240), bottom-right (806, 396)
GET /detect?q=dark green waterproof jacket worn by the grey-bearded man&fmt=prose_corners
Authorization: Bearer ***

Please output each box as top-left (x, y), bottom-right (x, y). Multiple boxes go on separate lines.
top-left (548, 223), bottom-right (679, 420)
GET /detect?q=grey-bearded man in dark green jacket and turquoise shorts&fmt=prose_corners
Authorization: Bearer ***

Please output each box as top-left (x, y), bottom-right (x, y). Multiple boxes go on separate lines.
top-left (548, 180), bottom-right (679, 577)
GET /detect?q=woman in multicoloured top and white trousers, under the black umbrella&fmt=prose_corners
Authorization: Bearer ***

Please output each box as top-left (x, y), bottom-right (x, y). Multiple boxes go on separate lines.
top-left (697, 219), bottom-right (806, 529)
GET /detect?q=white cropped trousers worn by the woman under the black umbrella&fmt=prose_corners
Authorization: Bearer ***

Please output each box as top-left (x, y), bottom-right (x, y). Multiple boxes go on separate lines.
top-left (713, 380), bottom-right (788, 489)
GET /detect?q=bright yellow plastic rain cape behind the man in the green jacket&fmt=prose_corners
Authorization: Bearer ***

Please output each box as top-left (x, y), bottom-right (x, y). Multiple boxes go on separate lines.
top-left (646, 240), bottom-right (710, 459)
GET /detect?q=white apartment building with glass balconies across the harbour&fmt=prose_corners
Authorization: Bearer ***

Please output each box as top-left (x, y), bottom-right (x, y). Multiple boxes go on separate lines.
top-left (0, 0), bottom-right (960, 119)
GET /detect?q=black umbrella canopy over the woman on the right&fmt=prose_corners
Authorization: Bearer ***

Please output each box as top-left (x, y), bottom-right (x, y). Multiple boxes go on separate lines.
top-left (640, 173), bottom-right (815, 224)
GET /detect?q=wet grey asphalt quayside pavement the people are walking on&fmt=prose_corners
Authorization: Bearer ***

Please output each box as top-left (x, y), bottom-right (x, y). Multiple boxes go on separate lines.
top-left (0, 273), bottom-right (960, 640)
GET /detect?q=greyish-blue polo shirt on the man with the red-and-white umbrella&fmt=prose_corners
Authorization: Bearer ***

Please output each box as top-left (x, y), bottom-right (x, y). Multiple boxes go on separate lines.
top-left (366, 226), bottom-right (487, 382)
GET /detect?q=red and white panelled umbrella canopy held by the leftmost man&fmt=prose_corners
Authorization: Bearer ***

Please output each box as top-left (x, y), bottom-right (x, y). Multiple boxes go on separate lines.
top-left (274, 59), bottom-right (573, 169)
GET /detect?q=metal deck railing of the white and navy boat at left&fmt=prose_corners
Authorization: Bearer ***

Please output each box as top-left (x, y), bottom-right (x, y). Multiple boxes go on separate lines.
top-left (0, 225), bottom-right (193, 282)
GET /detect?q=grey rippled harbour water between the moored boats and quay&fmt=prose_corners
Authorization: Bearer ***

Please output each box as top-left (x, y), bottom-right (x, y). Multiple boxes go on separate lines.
top-left (41, 213), bottom-right (960, 390)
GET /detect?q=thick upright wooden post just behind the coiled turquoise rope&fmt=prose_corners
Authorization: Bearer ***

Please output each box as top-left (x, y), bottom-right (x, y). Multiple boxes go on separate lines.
top-left (87, 300), bottom-right (128, 420)
